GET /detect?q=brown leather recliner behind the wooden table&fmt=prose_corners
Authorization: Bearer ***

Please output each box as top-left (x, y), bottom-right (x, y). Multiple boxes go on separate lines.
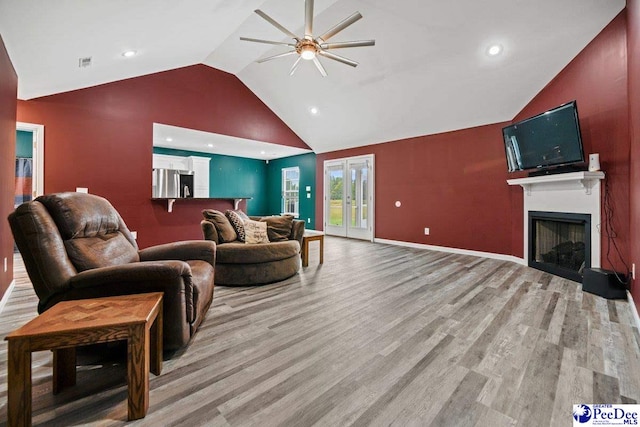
top-left (9, 193), bottom-right (216, 350)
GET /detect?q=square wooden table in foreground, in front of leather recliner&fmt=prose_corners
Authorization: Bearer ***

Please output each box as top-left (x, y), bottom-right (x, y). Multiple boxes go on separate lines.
top-left (5, 292), bottom-right (162, 426)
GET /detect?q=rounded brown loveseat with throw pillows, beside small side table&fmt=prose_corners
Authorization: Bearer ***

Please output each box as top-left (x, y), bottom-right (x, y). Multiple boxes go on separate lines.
top-left (201, 209), bottom-right (304, 286)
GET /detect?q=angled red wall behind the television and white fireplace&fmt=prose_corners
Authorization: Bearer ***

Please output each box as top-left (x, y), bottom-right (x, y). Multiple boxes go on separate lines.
top-left (514, 11), bottom-right (631, 272)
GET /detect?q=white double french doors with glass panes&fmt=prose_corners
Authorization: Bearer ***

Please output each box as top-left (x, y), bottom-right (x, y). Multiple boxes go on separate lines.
top-left (324, 154), bottom-right (374, 241)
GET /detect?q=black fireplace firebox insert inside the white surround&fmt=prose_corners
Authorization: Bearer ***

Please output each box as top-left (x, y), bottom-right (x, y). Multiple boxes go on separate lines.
top-left (527, 211), bottom-right (591, 282)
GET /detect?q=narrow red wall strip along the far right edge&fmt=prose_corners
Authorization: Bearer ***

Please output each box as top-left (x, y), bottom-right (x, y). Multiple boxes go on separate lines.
top-left (627, 0), bottom-right (640, 308)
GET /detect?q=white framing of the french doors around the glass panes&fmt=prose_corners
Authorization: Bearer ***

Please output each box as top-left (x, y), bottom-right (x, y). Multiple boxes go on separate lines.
top-left (322, 154), bottom-right (376, 242)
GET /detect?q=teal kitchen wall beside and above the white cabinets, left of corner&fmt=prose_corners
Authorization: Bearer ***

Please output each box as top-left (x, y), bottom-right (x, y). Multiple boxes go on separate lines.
top-left (153, 147), bottom-right (268, 215)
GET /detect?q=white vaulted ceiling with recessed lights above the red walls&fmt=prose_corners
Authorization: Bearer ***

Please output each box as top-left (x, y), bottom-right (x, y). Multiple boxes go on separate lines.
top-left (0, 0), bottom-right (625, 152)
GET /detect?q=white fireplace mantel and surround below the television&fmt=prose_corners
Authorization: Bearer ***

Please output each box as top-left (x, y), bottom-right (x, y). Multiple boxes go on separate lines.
top-left (507, 171), bottom-right (605, 268)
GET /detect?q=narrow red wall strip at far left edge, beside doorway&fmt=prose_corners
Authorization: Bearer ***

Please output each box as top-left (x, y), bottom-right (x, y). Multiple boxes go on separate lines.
top-left (0, 36), bottom-right (18, 298)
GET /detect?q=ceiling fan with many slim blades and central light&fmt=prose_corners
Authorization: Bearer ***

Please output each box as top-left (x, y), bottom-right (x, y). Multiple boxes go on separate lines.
top-left (240, 0), bottom-right (376, 77)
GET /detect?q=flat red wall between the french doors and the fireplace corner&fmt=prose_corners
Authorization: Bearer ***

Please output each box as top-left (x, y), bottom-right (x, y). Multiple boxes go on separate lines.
top-left (316, 123), bottom-right (522, 256)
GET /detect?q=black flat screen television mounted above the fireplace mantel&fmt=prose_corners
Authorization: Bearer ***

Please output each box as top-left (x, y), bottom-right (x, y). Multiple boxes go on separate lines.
top-left (502, 101), bottom-right (584, 173)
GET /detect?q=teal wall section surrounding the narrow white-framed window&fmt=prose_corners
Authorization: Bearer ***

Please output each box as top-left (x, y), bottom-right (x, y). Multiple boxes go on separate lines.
top-left (267, 153), bottom-right (316, 229)
